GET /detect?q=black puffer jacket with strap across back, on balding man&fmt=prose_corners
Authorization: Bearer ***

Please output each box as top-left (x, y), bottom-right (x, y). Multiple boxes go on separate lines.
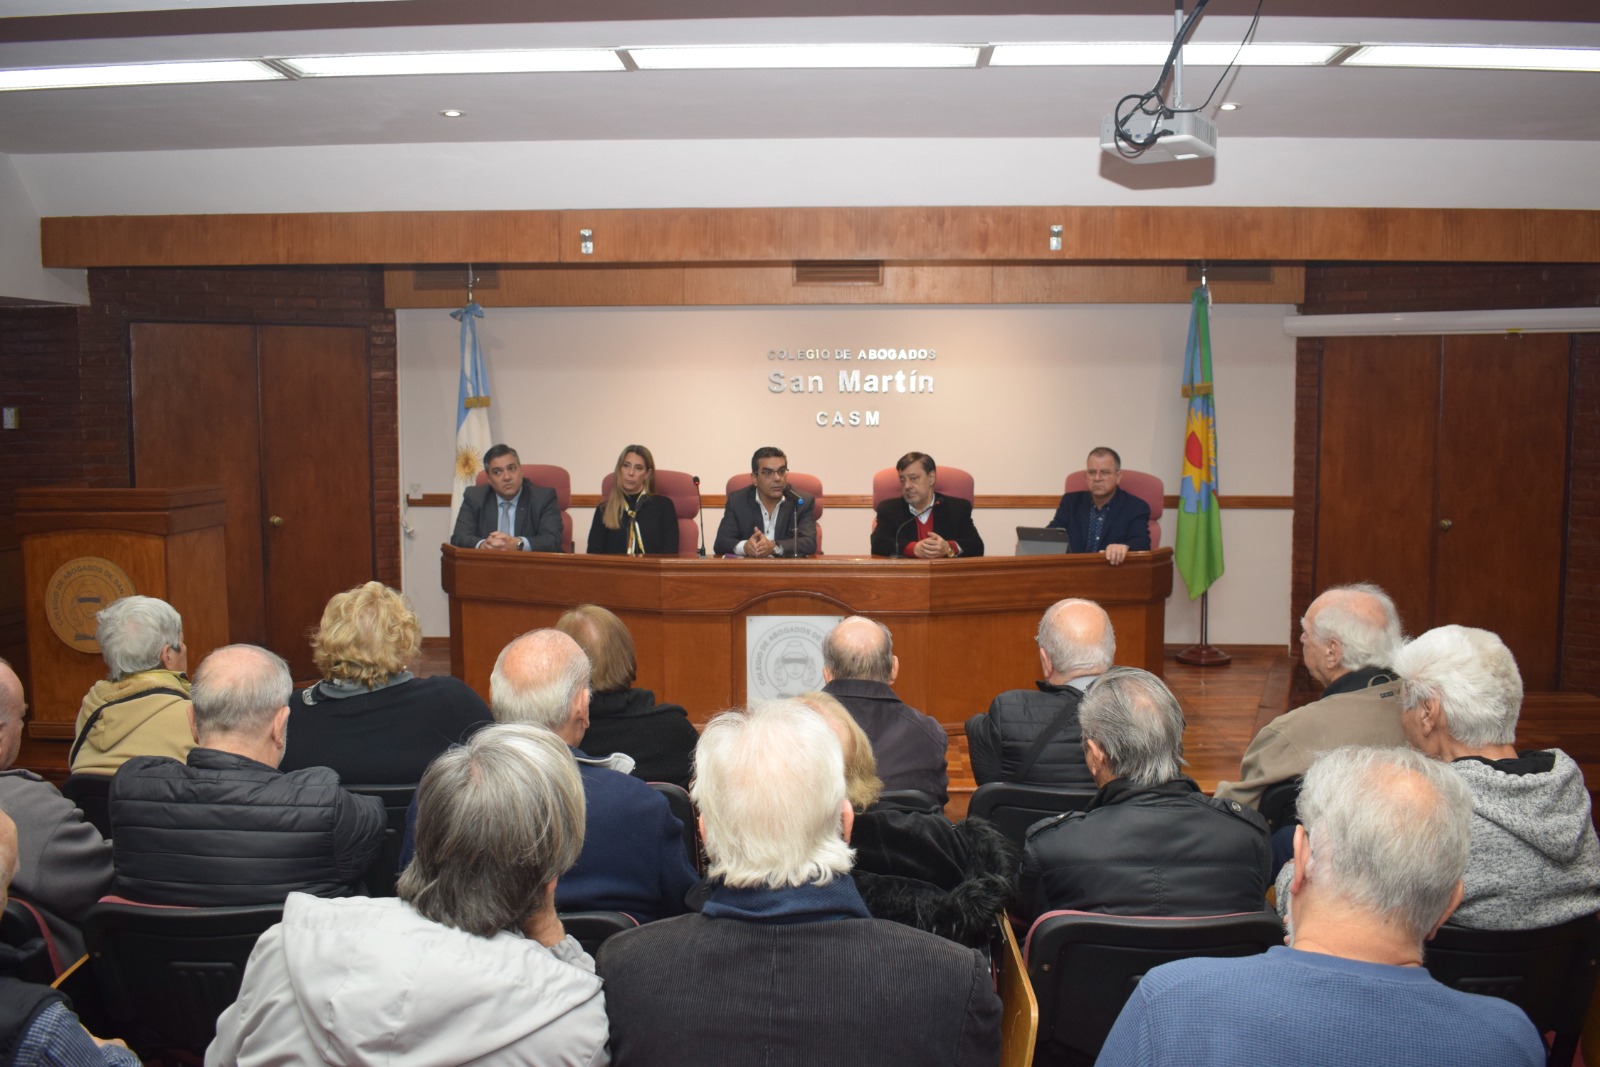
top-left (966, 681), bottom-right (1094, 789)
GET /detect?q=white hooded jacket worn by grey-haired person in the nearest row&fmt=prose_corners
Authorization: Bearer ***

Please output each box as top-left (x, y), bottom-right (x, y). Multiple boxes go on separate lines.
top-left (205, 893), bottom-right (608, 1067)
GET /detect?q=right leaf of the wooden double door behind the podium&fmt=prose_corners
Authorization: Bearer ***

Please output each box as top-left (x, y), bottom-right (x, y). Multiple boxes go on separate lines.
top-left (261, 326), bottom-right (376, 677)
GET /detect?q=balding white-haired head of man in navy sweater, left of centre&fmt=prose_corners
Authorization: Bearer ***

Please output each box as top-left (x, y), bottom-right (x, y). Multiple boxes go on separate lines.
top-left (490, 630), bottom-right (589, 745)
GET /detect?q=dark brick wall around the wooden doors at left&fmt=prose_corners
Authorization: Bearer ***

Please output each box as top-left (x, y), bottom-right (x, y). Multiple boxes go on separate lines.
top-left (0, 267), bottom-right (400, 687)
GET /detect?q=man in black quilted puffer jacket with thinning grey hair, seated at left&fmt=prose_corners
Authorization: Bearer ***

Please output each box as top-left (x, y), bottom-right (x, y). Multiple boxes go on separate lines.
top-left (109, 645), bottom-right (384, 907)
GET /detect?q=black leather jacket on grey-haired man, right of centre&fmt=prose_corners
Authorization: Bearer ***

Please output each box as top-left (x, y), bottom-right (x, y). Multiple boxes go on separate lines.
top-left (1018, 777), bottom-right (1272, 920)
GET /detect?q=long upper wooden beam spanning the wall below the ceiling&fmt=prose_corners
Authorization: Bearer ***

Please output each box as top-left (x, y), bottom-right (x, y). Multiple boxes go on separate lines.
top-left (40, 205), bottom-right (1600, 267)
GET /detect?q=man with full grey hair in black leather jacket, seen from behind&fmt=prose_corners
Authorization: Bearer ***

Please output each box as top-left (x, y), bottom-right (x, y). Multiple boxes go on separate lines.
top-left (1018, 667), bottom-right (1272, 920)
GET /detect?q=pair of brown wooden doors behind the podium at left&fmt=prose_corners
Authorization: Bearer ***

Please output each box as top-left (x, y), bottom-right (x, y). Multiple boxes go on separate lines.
top-left (131, 323), bottom-right (374, 678)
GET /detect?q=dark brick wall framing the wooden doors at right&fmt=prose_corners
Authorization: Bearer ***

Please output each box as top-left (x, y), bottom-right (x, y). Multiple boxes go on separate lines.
top-left (1288, 262), bottom-right (1600, 702)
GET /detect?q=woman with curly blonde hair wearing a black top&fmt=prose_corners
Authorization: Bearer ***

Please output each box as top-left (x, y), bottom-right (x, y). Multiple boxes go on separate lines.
top-left (282, 582), bottom-right (493, 785)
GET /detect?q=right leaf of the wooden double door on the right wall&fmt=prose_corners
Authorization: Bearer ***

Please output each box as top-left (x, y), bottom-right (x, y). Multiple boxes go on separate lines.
top-left (1432, 334), bottom-right (1570, 689)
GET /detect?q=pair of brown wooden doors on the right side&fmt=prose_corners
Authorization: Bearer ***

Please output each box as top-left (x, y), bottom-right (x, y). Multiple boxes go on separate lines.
top-left (1315, 334), bottom-right (1570, 689)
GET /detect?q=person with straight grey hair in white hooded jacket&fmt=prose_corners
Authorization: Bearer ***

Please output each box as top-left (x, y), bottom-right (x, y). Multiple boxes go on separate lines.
top-left (205, 725), bottom-right (606, 1067)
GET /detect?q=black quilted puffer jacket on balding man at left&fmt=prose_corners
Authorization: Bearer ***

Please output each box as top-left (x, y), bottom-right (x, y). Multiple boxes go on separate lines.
top-left (110, 749), bottom-right (384, 907)
